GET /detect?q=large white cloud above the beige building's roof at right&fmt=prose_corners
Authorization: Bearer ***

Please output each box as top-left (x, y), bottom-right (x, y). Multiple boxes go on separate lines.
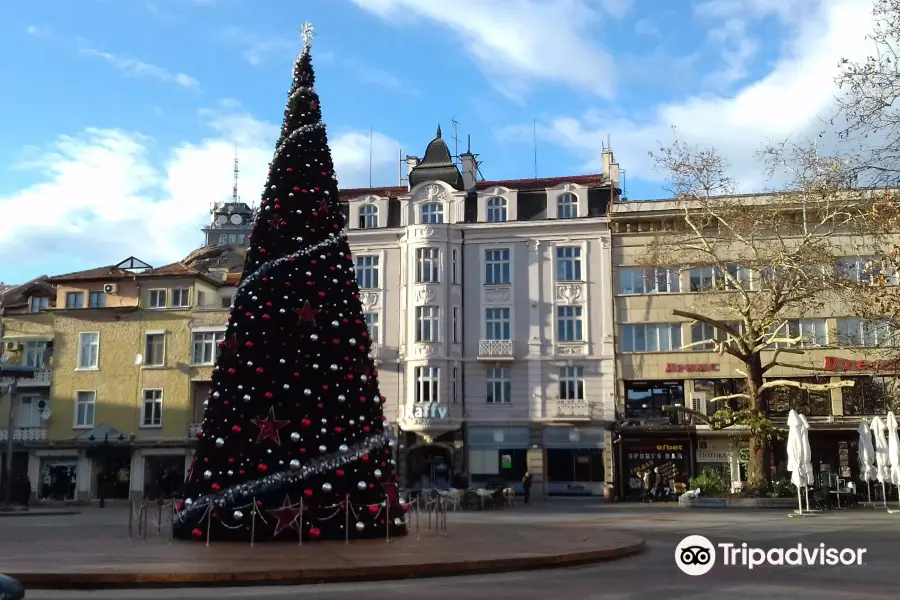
top-left (520, 0), bottom-right (872, 190)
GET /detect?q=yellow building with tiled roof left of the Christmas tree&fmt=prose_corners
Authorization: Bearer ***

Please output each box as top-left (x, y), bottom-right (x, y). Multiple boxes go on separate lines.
top-left (0, 257), bottom-right (234, 502)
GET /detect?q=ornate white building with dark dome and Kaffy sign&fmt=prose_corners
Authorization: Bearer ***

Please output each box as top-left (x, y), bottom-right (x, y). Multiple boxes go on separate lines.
top-left (341, 132), bottom-right (618, 495)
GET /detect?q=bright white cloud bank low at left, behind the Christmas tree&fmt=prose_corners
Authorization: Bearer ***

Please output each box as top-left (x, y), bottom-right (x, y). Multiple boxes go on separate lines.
top-left (0, 102), bottom-right (400, 279)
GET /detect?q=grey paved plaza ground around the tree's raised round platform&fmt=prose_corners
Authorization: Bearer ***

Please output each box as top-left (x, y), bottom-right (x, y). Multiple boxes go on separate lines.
top-left (7, 501), bottom-right (900, 600)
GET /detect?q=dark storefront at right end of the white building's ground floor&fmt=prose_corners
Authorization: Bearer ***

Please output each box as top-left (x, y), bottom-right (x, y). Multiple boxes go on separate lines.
top-left (542, 427), bottom-right (606, 496)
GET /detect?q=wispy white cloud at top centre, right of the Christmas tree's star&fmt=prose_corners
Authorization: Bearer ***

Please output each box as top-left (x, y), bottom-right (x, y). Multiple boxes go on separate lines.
top-left (351, 0), bottom-right (623, 98)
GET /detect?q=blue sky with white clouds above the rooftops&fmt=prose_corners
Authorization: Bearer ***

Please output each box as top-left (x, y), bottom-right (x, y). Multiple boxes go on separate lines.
top-left (0, 0), bottom-right (872, 283)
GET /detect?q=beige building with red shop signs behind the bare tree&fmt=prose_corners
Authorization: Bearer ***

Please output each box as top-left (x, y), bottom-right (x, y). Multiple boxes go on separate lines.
top-left (610, 197), bottom-right (900, 496)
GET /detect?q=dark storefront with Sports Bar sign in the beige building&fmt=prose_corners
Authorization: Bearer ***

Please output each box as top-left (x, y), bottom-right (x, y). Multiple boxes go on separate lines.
top-left (620, 437), bottom-right (694, 499)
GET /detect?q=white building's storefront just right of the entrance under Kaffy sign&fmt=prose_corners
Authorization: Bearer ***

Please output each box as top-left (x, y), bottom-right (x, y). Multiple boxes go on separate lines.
top-left (466, 426), bottom-right (530, 489)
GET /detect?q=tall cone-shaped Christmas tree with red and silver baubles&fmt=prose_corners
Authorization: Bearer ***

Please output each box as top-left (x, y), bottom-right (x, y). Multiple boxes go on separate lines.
top-left (174, 24), bottom-right (407, 541)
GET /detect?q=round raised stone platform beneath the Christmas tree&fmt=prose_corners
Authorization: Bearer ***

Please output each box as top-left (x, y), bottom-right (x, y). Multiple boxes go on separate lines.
top-left (0, 509), bottom-right (643, 589)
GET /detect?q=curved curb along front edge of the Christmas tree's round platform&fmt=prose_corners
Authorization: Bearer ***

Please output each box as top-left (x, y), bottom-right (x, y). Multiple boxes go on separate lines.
top-left (8, 540), bottom-right (645, 590)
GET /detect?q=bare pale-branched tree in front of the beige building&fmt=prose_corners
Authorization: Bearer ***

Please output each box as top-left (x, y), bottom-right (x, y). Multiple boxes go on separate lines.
top-left (645, 139), bottom-right (879, 490)
